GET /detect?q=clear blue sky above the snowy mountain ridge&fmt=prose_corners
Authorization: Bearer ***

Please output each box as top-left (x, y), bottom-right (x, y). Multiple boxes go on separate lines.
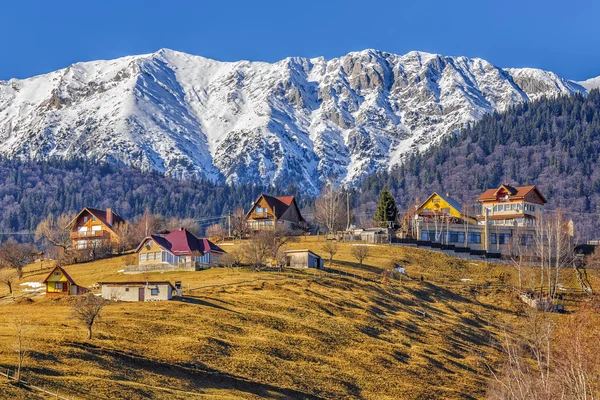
top-left (0, 0), bottom-right (600, 80)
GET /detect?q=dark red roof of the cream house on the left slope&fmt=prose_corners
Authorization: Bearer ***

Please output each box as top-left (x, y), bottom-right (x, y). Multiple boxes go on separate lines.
top-left (135, 228), bottom-right (225, 256)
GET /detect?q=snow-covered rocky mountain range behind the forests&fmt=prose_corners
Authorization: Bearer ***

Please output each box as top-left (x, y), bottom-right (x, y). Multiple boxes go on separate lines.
top-left (0, 49), bottom-right (586, 192)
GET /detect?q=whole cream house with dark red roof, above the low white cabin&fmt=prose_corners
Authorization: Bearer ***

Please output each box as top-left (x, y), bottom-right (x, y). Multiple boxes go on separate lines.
top-left (135, 228), bottom-right (225, 270)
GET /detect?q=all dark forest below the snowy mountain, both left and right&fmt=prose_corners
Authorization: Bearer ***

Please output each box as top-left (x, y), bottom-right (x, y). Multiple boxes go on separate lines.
top-left (0, 90), bottom-right (600, 240)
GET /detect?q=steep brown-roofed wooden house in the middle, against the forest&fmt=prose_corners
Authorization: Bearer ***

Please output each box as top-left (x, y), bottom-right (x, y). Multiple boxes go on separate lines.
top-left (246, 194), bottom-right (304, 231)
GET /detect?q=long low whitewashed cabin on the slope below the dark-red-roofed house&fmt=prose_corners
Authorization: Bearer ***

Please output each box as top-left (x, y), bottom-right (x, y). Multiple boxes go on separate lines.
top-left (100, 281), bottom-right (175, 301)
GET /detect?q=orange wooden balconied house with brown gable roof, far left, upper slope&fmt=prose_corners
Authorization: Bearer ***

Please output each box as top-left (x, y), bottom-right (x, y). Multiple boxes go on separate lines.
top-left (67, 207), bottom-right (124, 250)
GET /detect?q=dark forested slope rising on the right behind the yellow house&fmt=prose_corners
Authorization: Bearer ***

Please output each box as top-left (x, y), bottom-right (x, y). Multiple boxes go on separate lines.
top-left (360, 90), bottom-right (600, 240)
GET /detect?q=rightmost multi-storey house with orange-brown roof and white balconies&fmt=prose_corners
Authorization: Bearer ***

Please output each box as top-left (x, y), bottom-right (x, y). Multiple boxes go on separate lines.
top-left (477, 184), bottom-right (547, 226)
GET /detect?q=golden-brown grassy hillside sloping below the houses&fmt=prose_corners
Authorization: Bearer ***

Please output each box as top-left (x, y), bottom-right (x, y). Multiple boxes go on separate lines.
top-left (0, 239), bottom-right (588, 399)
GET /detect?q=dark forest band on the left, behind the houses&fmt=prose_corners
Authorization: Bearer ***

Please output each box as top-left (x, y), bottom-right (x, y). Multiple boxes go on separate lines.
top-left (0, 159), bottom-right (311, 240)
